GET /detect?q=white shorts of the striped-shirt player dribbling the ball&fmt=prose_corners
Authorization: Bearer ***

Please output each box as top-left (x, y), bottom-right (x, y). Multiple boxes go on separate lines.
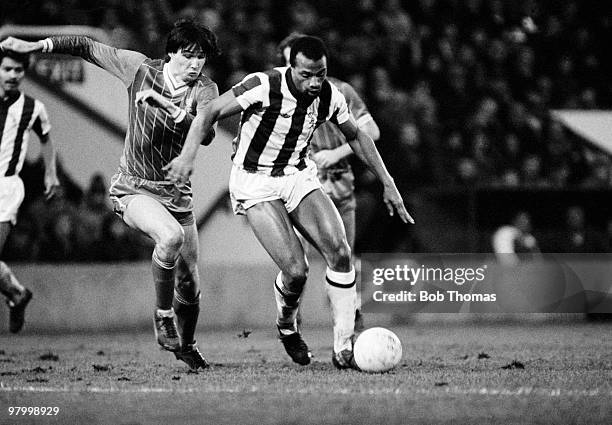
top-left (229, 161), bottom-right (321, 214)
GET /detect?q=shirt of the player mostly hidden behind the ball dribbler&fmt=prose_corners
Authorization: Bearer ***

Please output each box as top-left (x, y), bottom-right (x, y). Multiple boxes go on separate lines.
top-left (311, 77), bottom-right (373, 170)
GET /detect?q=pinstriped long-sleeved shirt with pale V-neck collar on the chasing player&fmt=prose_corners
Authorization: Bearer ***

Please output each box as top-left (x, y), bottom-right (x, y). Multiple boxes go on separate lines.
top-left (50, 36), bottom-right (219, 181)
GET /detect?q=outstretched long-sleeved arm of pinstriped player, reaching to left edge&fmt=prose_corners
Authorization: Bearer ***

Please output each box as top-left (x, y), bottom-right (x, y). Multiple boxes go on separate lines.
top-left (0, 36), bottom-right (147, 87)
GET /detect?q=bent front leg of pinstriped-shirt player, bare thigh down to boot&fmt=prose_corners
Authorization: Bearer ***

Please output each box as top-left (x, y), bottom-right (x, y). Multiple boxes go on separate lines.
top-left (123, 195), bottom-right (185, 351)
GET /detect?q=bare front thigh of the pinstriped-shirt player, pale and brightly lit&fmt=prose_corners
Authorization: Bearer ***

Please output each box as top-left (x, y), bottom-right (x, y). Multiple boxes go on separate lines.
top-left (123, 195), bottom-right (183, 243)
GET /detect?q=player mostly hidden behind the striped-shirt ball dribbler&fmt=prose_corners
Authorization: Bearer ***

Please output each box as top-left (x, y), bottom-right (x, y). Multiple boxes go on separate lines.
top-left (278, 33), bottom-right (380, 331)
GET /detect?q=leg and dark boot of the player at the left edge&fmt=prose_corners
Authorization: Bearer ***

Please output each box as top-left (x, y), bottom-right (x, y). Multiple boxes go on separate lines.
top-left (0, 221), bottom-right (32, 333)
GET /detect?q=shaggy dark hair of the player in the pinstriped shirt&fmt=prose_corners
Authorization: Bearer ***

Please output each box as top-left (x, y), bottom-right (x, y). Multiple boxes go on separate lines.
top-left (166, 20), bottom-right (221, 59)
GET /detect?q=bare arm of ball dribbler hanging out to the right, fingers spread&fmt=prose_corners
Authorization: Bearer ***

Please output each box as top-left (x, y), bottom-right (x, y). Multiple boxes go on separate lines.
top-left (339, 119), bottom-right (414, 224)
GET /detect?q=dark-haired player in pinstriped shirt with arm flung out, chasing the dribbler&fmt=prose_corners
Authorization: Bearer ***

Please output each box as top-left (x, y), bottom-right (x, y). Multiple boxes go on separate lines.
top-left (2, 21), bottom-right (218, 369)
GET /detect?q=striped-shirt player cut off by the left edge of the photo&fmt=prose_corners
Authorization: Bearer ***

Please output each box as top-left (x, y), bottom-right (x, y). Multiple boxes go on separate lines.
top-left (0, 49), bottom-right (59, 333)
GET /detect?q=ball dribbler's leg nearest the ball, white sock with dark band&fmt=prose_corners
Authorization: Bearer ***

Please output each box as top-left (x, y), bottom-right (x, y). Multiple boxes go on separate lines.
top-left (290, 190), bottom-right (356, 367)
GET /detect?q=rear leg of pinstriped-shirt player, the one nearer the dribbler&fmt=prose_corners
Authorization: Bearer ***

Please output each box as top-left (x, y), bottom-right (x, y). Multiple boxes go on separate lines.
top-left (173, 224), bottom-right (209, 370)
